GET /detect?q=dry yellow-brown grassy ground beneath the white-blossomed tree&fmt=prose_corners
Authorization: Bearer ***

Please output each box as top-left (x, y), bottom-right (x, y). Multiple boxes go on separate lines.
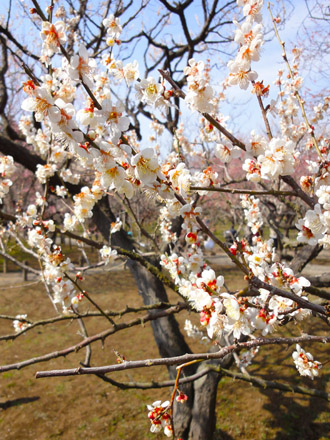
top-left (0, 251), bottom-right (330, 440)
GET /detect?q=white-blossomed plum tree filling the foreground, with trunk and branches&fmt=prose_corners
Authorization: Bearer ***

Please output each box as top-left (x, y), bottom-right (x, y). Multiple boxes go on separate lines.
top-left (0, 0), bottom-right (330, 440)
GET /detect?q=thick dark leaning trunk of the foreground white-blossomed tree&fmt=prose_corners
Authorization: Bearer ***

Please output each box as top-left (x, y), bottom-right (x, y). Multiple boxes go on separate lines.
top-left (93, 200), bottom-right (228, 440)
